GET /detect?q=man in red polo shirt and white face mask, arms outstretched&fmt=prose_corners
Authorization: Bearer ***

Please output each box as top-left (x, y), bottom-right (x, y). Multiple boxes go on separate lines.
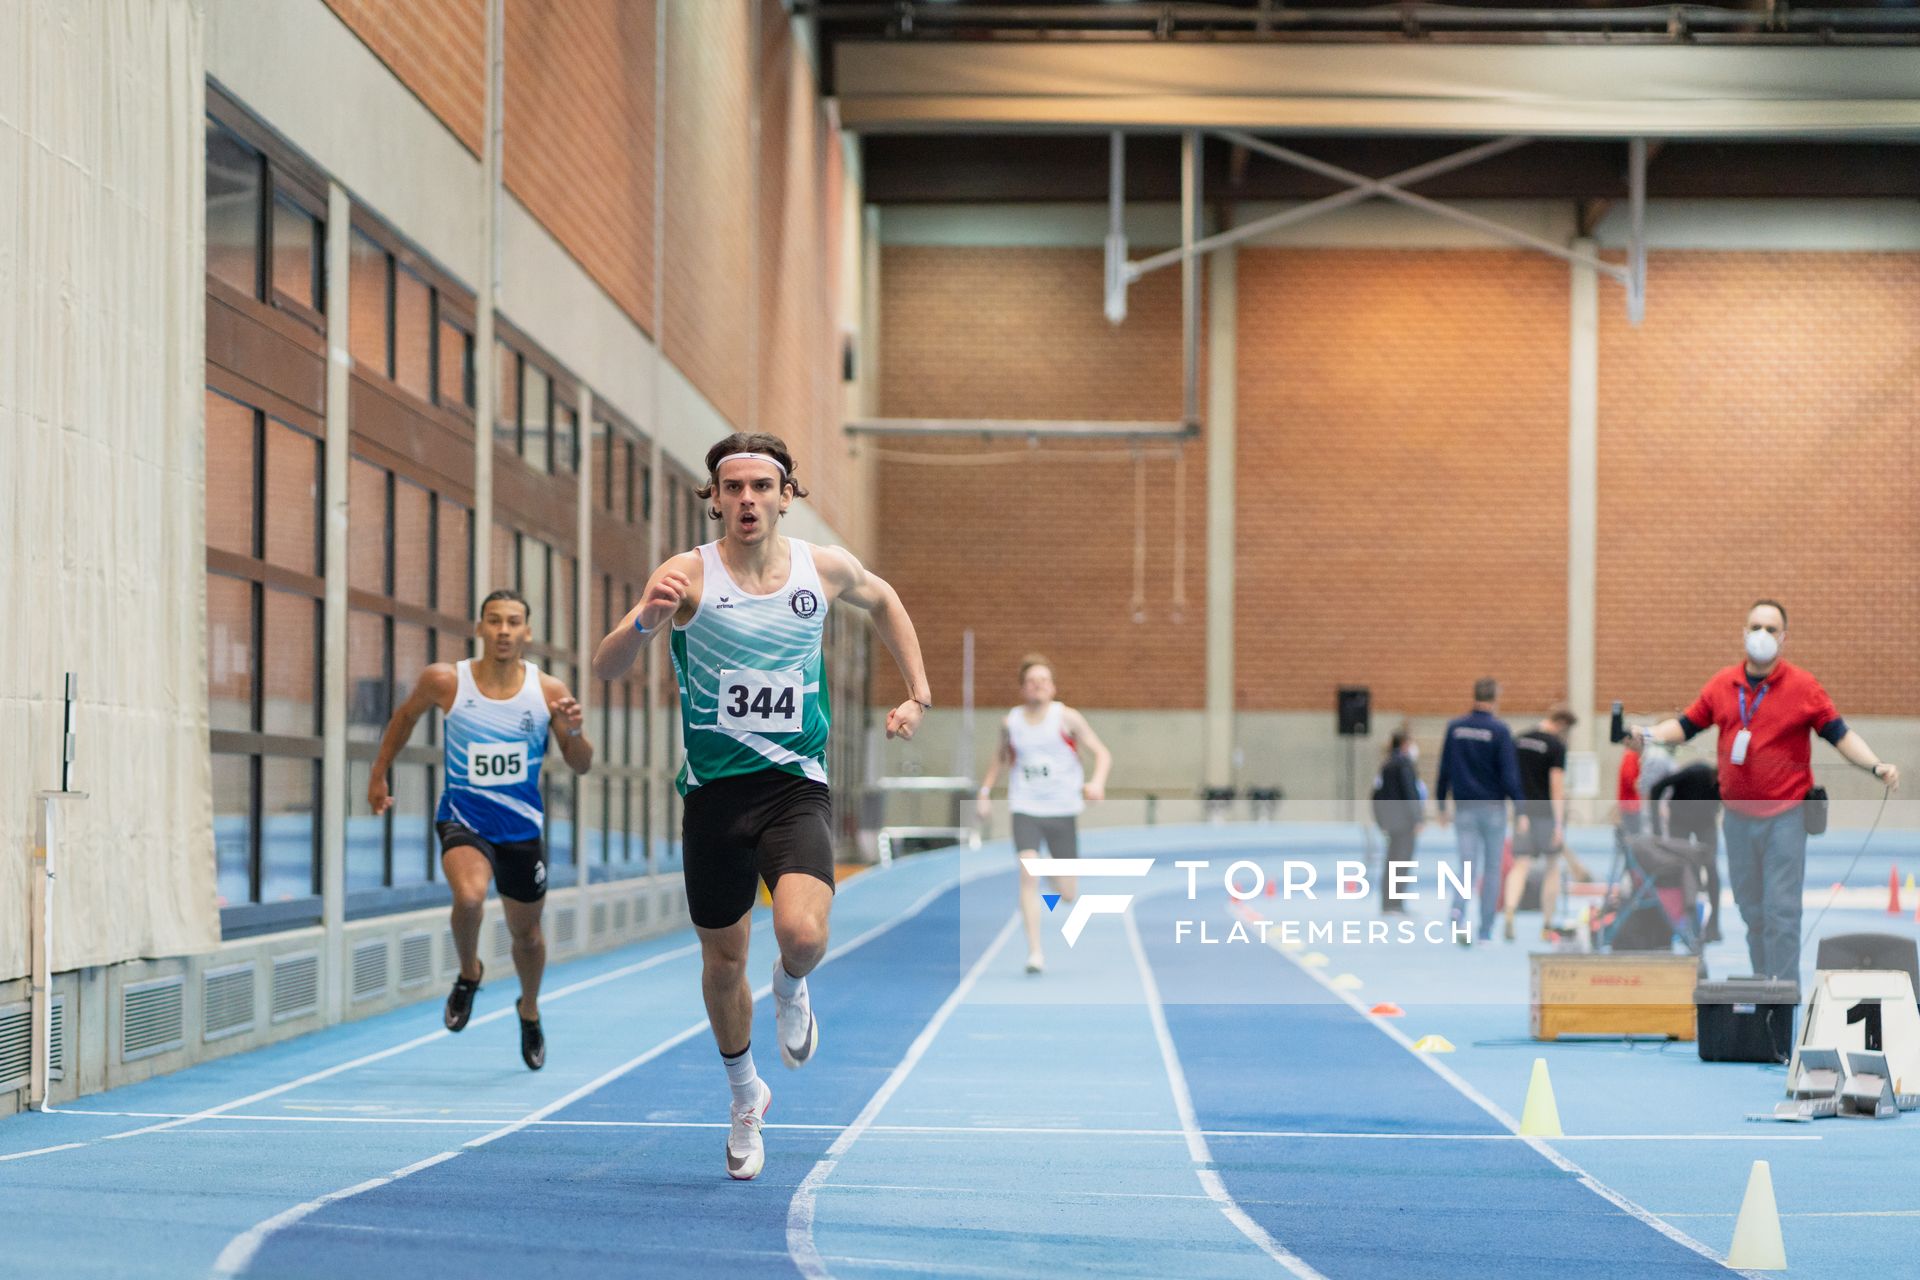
top-left (1628, 601), bottom-right (1901, 981)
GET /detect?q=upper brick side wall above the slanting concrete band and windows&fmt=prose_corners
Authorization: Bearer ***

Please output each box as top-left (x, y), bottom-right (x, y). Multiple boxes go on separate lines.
top-left (326, 0), bottom-right (862, 532)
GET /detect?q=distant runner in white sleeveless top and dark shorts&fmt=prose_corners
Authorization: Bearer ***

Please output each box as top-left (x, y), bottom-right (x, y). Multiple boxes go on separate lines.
top-left (979, 654), bottom-right (1114, 973)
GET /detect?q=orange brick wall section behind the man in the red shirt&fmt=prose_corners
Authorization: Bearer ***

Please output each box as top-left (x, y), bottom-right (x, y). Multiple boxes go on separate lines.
top-left (1597, 253), bottom-right (1920, 716)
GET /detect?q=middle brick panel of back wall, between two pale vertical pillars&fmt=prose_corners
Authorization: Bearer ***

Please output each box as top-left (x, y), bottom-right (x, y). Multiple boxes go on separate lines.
top-left (1235, 249), bottom-right (1569, 714)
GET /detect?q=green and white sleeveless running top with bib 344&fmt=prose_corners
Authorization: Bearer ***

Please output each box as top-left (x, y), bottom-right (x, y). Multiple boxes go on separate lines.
top-left (672, 537), bottom-right (828, 794)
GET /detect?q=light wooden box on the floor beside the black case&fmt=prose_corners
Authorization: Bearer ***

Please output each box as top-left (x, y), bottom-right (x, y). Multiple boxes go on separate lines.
top-left (1532, 952), bottom-right (1699, 1040)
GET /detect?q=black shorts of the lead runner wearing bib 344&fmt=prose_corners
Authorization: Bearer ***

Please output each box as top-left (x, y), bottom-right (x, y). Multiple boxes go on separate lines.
top-left (680, 770), bottom-right (833, 929)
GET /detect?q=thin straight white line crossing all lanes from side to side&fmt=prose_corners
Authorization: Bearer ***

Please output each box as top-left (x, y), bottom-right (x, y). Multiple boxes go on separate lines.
top-left (52, 1111), bottom-right (1824, 1159)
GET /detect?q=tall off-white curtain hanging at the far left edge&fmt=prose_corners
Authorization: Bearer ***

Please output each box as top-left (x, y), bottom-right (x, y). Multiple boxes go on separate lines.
top-left (0, 0), bottom-right (219, 979)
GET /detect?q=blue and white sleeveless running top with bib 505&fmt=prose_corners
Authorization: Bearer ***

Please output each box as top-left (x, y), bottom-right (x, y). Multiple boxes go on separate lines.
top-left (436, 658), bottom-right (551, 841)
